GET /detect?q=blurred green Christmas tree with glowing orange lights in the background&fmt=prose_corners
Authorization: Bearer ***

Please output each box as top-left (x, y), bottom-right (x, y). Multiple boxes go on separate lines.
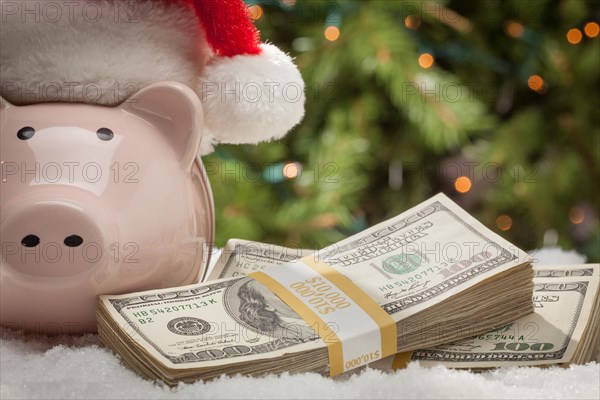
top-left (204, 0), bottom-right (600, 262)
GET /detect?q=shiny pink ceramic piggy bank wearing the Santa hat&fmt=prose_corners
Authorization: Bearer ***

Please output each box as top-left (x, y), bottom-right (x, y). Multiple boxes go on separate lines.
top-left (0, 82), bottom-right (214, 335)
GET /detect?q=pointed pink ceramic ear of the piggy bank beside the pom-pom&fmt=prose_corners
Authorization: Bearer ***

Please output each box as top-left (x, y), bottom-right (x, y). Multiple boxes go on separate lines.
top-left (121, 82), bottom-right (202, 170)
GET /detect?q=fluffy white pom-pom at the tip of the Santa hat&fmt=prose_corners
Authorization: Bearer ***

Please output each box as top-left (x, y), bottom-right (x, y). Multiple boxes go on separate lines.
top-left (197, 44), bottom-right (305, 155)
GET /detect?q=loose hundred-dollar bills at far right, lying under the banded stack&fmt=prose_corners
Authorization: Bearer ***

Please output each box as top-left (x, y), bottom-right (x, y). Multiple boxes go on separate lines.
top-left (371, 264), bottom-right (600, 370)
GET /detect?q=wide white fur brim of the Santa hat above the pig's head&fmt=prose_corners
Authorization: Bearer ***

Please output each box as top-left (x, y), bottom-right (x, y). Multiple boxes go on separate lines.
top-left (0, 0), bottom-right (211, 105)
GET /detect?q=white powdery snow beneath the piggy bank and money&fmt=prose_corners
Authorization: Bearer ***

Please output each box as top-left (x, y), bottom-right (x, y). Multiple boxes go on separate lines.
top-left (0, 248), bottom-right (600, 399)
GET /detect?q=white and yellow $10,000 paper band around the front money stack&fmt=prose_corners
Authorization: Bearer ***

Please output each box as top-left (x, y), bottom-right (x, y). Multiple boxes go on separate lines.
top-left (249, 256), bottom-right (397, 376)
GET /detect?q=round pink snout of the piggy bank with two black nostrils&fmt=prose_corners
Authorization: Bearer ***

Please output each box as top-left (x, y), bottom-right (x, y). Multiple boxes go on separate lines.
top-left (2, 200), bottom-right (108, 277)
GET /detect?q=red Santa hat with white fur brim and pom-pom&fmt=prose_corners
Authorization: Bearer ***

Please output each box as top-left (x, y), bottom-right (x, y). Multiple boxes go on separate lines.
top-left (0, 0), bottom-right (305, 154)
